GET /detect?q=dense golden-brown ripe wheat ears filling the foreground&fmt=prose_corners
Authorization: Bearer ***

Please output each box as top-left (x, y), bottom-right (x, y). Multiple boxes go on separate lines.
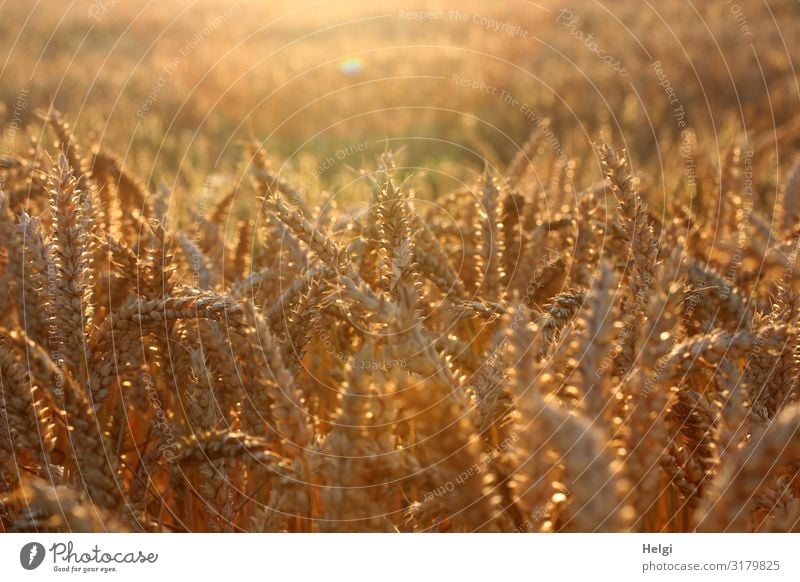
top-left (0, 112), bottom-right (800, 532)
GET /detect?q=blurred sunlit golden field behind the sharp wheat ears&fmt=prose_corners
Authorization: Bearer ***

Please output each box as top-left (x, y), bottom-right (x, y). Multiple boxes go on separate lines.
top-left (0, 0), bottom-right (800, 198)
